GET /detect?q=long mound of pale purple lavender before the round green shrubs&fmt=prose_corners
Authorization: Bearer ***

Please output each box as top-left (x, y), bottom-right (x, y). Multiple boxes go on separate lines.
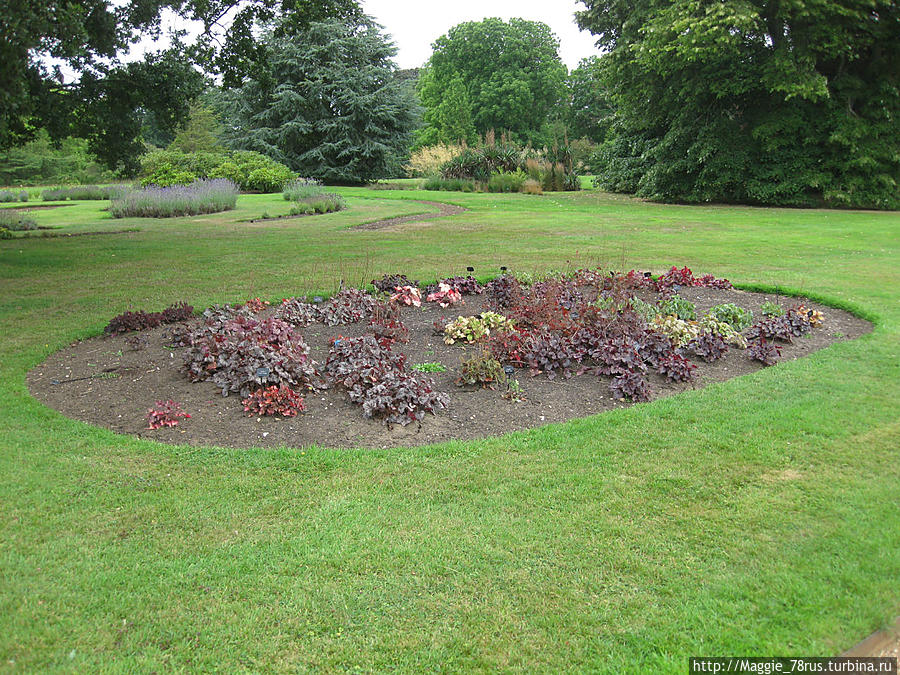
top-left (109, 178), bottom-right (238, 218)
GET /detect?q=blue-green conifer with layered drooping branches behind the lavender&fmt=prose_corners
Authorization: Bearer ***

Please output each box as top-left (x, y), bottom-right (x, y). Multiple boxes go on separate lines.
top-left (224, 17), bottom-right (417, 183)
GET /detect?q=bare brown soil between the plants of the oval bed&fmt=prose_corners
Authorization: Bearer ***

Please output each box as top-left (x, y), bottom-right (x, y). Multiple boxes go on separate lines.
top-left (27, 288), bottom-right (871, 448)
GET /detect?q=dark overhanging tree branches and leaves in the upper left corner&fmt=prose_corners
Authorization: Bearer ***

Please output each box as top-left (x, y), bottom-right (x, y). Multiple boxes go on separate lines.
top-left (0, 0), bottom-right (361, 170)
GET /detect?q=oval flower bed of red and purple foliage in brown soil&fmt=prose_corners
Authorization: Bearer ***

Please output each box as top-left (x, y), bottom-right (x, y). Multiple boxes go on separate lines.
top-left (28, 268), bottom-right (870, 447)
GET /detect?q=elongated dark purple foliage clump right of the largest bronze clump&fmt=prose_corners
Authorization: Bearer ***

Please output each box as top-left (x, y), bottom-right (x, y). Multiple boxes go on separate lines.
top-left (325, 336), bottom-right (450, 425)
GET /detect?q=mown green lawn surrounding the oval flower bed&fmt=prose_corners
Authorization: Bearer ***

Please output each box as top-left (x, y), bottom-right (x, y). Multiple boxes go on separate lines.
top-left (0, 189), bottom-right (900, 673)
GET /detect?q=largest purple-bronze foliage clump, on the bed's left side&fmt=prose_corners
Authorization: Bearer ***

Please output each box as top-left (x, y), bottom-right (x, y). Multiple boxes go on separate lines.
top-left (184, 314), bottom-right (321, 398)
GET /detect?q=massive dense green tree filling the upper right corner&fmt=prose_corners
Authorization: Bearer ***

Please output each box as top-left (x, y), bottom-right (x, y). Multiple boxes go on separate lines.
top-left (577, 0), bottom-right (900, 208)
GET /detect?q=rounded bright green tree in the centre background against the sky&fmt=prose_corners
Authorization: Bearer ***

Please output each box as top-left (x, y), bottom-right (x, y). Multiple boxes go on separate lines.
top-left (419, 19), bottom-right (566, 142)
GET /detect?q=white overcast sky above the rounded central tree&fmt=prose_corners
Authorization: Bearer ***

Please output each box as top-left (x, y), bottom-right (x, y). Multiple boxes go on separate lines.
top-left (362, 0), bottom-right (600, 70)
